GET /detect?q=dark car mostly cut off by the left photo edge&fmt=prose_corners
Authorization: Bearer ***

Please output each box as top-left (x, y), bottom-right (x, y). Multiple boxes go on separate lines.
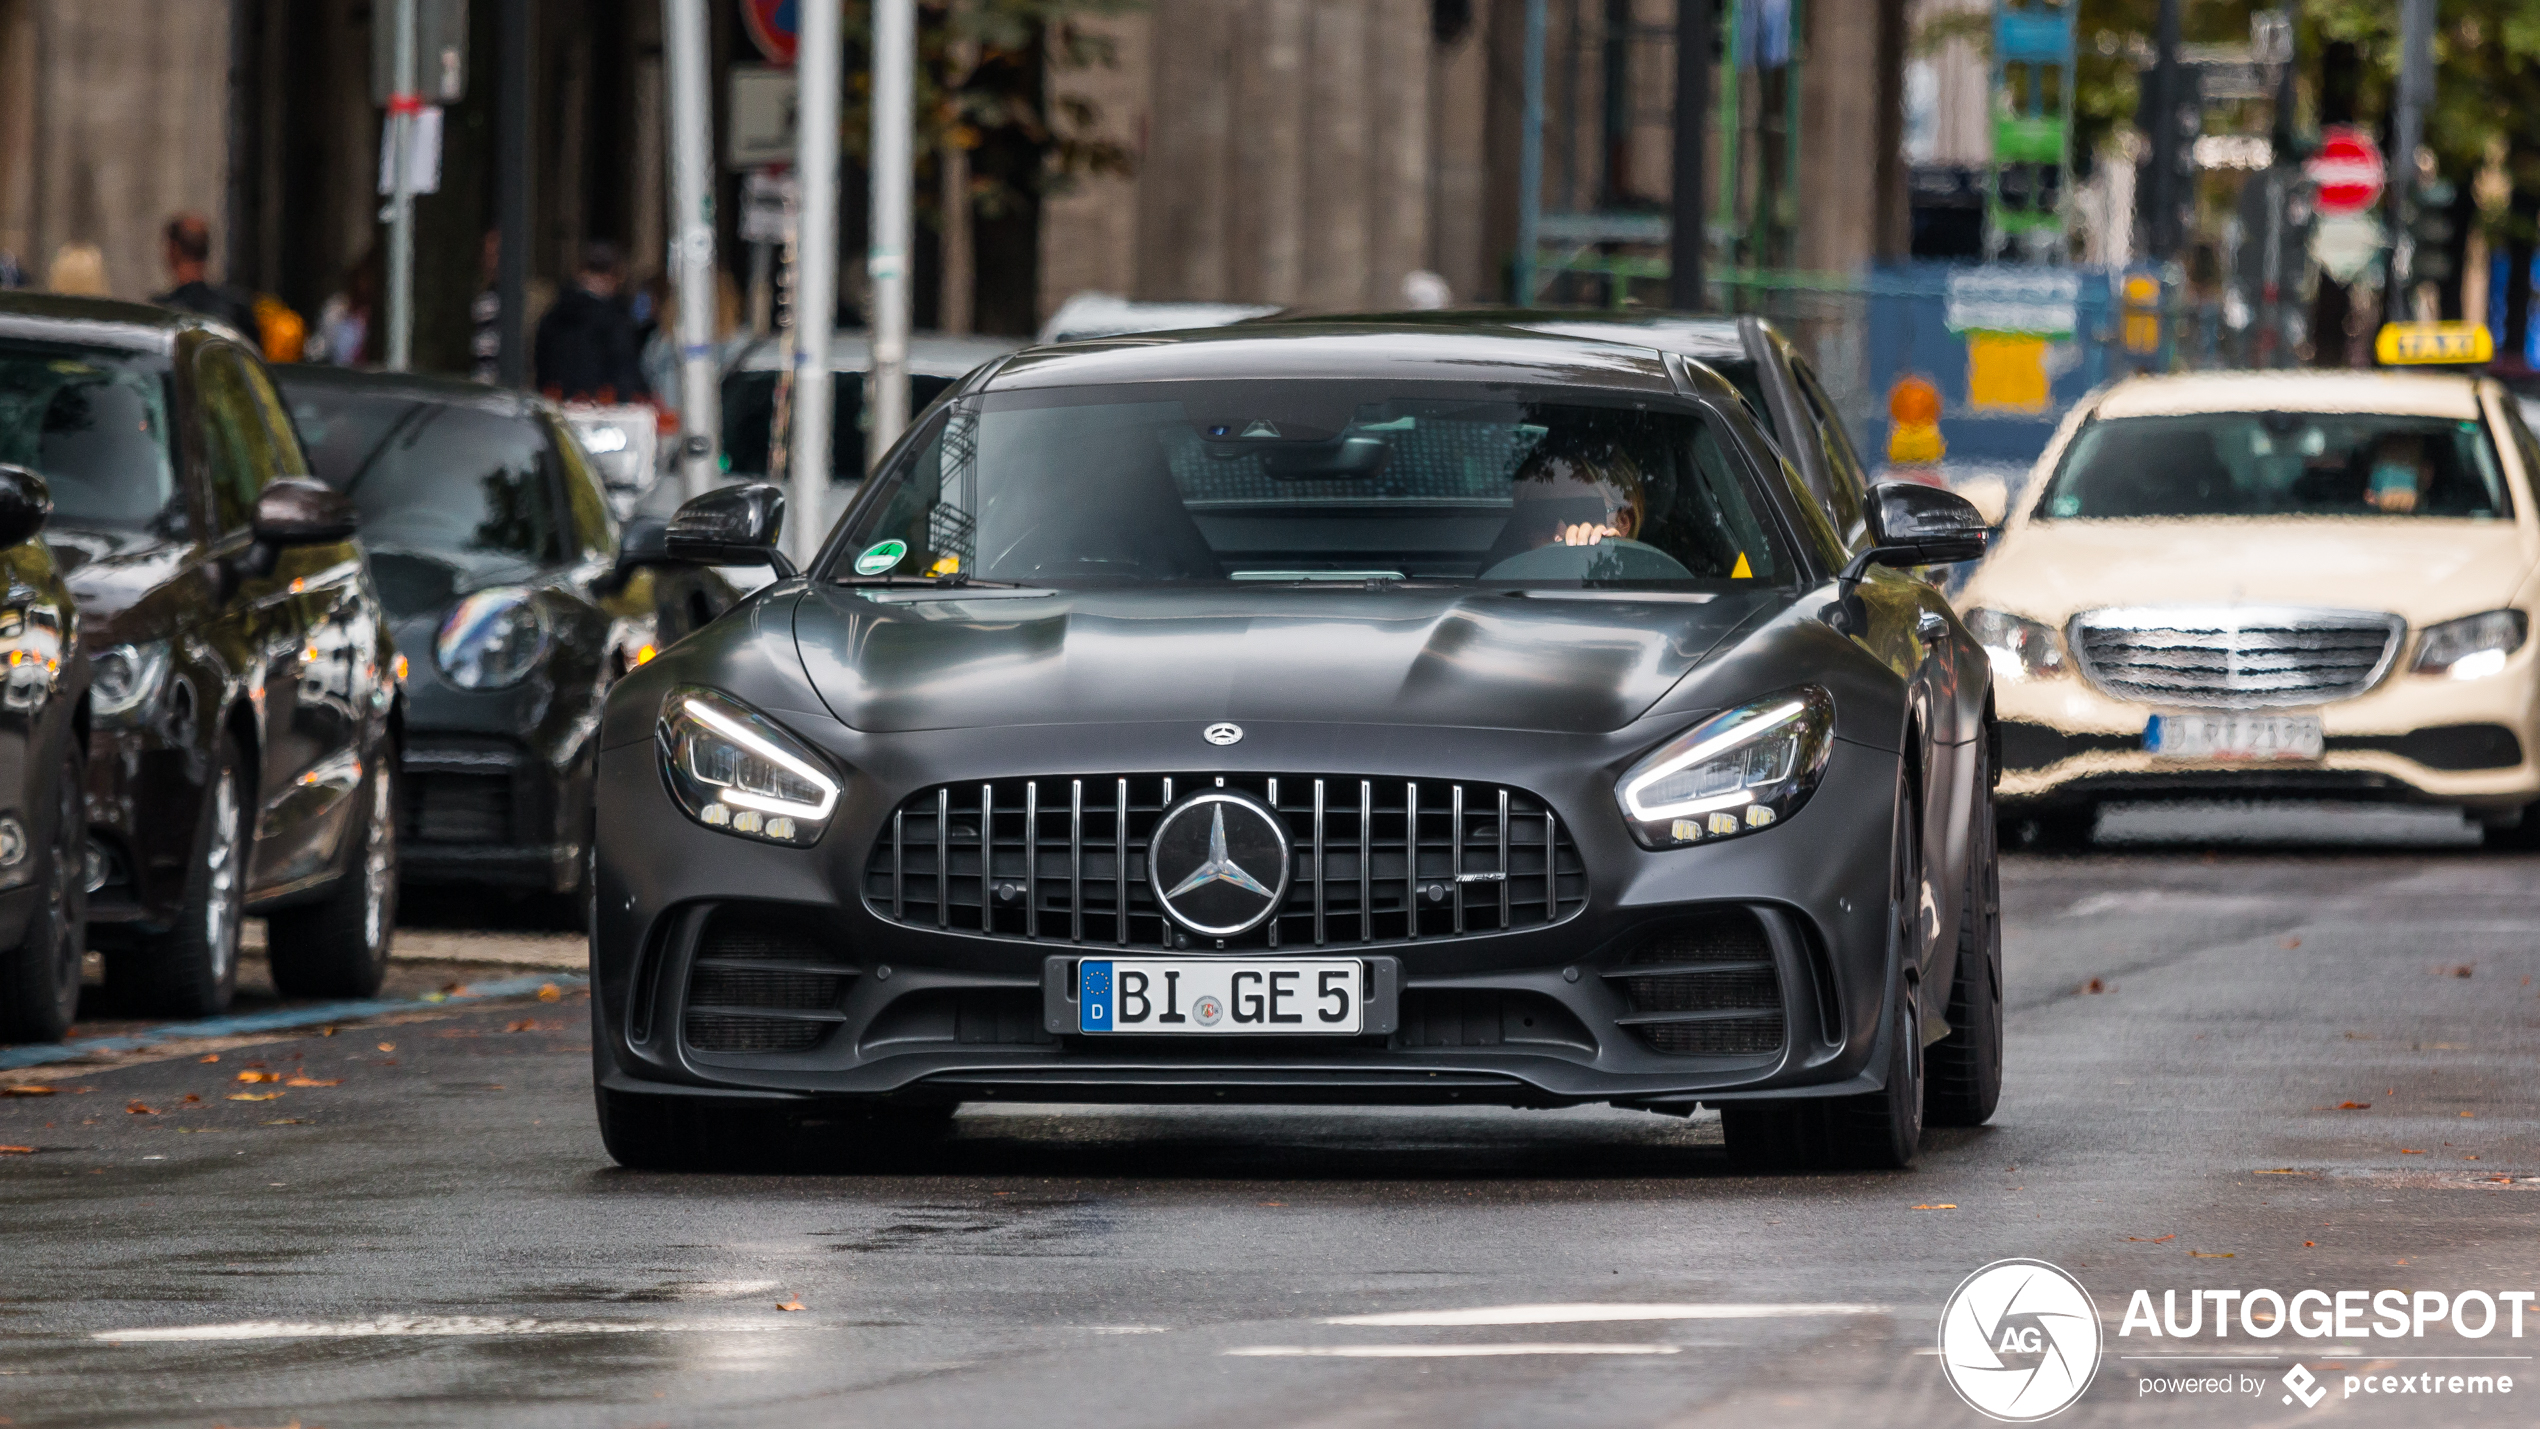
top-left (0, 436), bottom-right (83, 1041)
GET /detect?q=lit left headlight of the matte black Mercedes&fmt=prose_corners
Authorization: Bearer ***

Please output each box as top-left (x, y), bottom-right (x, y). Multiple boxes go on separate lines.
top-left (653, 685), bottom-right (838, 845)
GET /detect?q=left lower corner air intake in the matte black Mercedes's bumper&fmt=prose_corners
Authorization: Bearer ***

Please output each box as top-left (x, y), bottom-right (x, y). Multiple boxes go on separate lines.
top-left (683, 904), bottom-right (859, 1053)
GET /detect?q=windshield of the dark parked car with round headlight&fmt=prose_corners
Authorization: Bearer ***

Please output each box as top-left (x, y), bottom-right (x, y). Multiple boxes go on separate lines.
top-left (290, 386), bottom-right (564, 571)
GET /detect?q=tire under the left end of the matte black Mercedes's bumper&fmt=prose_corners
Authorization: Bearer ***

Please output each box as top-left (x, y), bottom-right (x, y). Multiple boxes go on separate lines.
top-left (594, 1086), bottom-right (953, 1173)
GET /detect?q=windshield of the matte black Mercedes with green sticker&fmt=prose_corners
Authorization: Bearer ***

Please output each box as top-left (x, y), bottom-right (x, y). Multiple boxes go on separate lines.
top-left (831, 381), bottom-right (1791, 589)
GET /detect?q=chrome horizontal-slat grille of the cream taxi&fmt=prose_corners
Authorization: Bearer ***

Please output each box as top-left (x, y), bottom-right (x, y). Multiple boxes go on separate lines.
top-left (2070, 607), bottom-right (2408, 706)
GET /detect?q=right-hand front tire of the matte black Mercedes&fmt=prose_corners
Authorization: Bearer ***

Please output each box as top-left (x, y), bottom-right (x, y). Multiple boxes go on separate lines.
top-left (1720, 774), bottom-right (1925, 1170)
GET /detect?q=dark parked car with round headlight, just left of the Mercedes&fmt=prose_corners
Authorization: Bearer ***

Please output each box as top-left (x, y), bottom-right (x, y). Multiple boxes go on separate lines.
top-left (282, 368), bottom-right (734, 891)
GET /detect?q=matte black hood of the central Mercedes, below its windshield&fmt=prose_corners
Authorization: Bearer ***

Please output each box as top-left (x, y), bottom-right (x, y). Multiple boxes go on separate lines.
top-left (795, 589), bottom-right (1793, 734)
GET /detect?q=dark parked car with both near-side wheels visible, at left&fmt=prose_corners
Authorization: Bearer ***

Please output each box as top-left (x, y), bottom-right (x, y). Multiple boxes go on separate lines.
top-left (0, 294), bottom-right (399, 1015)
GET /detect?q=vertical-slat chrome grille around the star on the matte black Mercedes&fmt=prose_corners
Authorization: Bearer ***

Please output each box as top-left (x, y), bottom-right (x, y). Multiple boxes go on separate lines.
top-left (864, 774), bottom-right (1588, 947)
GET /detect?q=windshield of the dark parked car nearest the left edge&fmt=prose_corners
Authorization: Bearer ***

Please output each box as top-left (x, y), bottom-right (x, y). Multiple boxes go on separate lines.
top-left (0, 340), bottom-right (183, 530)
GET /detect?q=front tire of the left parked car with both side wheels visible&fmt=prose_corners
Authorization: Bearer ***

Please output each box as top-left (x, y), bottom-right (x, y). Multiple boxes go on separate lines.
top-left (107, 734), bottom-right (257, 1018)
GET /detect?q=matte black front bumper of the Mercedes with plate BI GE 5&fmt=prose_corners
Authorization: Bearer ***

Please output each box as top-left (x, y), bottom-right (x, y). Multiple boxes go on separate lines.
top-left (592, 713), bottom-right (1895, 1112)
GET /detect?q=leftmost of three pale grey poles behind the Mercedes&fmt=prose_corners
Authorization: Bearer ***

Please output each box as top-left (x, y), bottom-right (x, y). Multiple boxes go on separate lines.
top-left (663, 0), bottom-right (724, 497)
